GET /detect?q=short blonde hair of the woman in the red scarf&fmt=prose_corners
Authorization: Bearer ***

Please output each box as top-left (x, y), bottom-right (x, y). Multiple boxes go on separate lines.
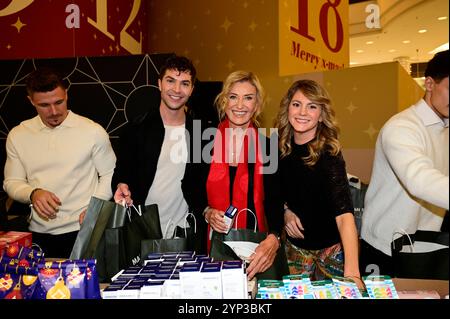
top-left (214, 71), bottom-right (266, 126)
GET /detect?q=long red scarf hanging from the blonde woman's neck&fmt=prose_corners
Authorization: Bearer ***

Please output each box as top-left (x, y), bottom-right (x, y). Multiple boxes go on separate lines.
top-left (206, 119), bottom-right (267, 251)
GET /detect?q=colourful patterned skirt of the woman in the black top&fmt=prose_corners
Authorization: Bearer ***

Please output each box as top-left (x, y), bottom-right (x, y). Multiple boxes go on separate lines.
top-left (285, 240), bottom-right (344, 280)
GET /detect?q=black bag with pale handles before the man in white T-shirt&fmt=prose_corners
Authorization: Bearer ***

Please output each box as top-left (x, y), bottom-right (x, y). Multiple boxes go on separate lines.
top-left (141, 213), bottom-right (197, 259)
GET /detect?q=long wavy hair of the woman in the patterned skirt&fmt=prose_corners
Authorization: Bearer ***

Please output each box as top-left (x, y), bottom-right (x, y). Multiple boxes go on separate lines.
top-left (275, 80), bottom-right (341, 166)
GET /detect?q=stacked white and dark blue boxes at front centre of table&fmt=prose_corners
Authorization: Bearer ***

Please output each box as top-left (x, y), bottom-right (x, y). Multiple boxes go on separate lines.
top-left (102, 252), bottom-right (248, 299)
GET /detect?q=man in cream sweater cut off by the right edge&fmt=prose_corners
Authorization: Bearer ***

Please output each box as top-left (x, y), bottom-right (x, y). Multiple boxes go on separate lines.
top-left (360, 50), bottom-right (449, 275)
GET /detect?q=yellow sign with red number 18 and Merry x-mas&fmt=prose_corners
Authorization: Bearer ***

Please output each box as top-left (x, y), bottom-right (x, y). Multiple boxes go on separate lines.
top-left (278, 0), bottom-right (349, 76)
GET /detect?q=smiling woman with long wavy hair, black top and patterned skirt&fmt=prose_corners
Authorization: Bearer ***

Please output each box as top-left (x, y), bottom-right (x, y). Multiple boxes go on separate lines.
top-left (276, 80), bottom-right (360, 284)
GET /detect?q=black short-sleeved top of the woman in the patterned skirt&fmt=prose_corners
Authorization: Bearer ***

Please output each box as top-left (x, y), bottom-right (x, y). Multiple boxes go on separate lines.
top-left (280, 143), bottom-right (353, 250)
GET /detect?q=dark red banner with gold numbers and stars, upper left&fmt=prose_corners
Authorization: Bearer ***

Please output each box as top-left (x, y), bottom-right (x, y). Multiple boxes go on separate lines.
top-left (0, 0), bottom-right (148, 59)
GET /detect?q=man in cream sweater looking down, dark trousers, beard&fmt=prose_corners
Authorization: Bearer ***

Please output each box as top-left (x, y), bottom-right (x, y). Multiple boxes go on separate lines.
top-left (3, 68), bottom-right (116, 258)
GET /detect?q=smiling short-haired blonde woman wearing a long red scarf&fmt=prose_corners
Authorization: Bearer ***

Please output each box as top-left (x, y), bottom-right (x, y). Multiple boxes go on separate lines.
top-left (183, 71), bottom-right (287, 279)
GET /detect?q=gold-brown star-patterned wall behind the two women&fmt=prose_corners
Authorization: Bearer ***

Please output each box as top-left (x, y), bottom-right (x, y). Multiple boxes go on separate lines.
top-left (148, 0), bottom-right (423, 182)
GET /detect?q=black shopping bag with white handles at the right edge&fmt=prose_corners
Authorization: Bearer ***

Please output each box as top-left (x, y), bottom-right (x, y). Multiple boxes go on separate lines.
top-left (391, 230), bottom-right (449, 280)
